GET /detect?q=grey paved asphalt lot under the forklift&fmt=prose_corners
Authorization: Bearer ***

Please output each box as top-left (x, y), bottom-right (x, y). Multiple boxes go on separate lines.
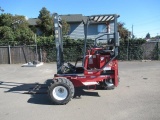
top-left (0, 61), bottom-right (160, 120)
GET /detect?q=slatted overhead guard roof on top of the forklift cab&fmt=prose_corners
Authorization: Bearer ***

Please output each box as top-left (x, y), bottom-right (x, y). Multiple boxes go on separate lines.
top-left (88, 14), bottom-right (119, 22)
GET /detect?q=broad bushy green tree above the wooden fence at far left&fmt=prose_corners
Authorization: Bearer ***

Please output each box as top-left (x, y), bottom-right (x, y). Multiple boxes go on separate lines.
top-left (0, 14), bottom-right (34, 45)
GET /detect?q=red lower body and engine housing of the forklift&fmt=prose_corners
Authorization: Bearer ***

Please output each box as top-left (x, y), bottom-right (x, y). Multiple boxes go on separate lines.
top-left (55, 48), bottom-right (118, 87)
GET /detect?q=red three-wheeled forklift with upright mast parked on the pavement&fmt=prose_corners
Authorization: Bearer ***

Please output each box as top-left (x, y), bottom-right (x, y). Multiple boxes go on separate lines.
top-left (48, 13), bottom-right (119, 105)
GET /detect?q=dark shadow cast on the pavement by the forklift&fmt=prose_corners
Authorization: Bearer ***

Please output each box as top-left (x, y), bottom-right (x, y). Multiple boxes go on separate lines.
top-left (0, 79), bottom-right (100, 105)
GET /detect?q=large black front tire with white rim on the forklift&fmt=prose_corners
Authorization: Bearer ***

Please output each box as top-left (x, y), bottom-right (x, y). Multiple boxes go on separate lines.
top-left (48, 78), bottom-right (75, 105)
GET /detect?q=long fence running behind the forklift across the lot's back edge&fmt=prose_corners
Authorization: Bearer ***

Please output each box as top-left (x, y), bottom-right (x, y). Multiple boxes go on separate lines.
top-left (0, 42), bottom-right (160, 64)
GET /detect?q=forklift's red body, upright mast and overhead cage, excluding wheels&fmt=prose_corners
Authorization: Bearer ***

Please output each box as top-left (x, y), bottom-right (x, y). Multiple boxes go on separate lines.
top-left (54, 13), bottom-right (119, 87)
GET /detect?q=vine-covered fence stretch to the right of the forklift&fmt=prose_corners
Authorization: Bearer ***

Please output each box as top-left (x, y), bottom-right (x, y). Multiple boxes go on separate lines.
top-left (118, 42), bottom-right (160, 60)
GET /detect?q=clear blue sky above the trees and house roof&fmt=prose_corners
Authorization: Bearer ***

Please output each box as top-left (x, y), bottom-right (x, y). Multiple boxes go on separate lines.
top-left (0, 0), bottom-right (160, 38)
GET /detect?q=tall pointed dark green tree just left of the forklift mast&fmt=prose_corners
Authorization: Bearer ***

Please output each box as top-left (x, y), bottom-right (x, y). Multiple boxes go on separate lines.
top-left (37, 7), bottom-right (54, 36)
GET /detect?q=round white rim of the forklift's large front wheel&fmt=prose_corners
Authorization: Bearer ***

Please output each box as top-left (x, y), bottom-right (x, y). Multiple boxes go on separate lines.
top-left (52, 86), bottom-right (68, 100)
